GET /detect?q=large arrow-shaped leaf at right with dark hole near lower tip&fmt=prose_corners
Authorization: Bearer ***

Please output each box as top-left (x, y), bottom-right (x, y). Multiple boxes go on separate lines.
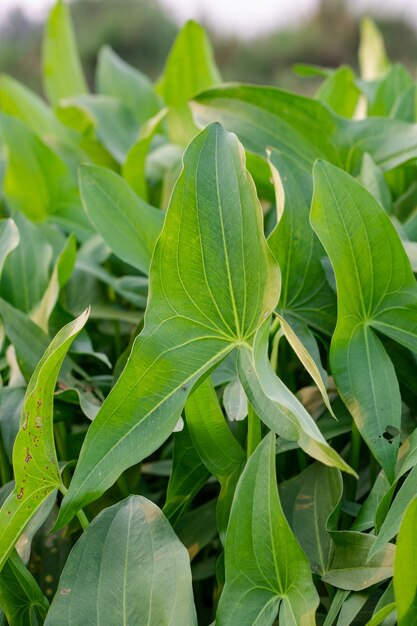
top-left (311, 163), bottom-right (417, 481)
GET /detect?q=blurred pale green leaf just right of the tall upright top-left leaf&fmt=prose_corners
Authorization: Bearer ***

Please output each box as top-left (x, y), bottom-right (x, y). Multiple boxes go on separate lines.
top-left (96, 46), bottom-right (160, 124)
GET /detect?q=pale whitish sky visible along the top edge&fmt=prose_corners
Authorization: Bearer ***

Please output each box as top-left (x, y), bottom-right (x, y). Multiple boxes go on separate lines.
top-left (0, 0), bottom-right (417, 36)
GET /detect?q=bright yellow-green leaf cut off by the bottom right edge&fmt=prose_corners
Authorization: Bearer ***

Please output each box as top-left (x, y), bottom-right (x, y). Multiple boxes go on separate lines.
top-left (394, 498), bottom-right (417, 626)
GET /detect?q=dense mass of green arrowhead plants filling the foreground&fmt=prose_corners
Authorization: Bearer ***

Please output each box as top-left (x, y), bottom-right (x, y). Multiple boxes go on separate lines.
top-left (0, 1), bottom-right (417, 626)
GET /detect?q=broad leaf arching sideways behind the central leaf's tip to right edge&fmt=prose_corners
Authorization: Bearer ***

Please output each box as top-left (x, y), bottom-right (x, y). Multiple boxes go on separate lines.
top-left (193, 85), bottom-right (417, 174)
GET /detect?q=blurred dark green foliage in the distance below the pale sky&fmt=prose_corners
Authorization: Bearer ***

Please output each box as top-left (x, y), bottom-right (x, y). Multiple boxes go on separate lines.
top-left (0, 0), bottom-right (417, 93)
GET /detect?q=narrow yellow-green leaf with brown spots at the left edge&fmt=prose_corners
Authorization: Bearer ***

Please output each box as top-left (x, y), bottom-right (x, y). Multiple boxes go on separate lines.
top-left (0, 312), bottom-right (88, 569)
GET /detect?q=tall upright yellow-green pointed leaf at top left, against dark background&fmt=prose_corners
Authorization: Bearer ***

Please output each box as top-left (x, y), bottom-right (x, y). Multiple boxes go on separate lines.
top-left (43, 0), bottom-right (88, 107)
